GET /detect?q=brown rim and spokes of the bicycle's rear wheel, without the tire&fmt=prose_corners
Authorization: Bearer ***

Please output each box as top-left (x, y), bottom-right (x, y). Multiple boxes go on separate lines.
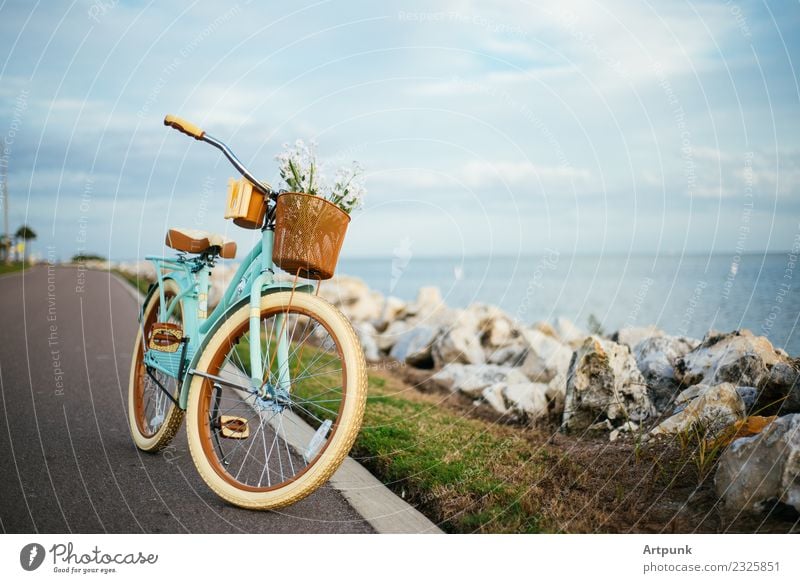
top-left (133, 291), bottom-right (182, 439)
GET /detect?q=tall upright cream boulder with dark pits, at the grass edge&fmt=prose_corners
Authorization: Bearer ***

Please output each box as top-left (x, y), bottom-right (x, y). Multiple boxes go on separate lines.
top-left (562, 336), bottom-right (655, 431)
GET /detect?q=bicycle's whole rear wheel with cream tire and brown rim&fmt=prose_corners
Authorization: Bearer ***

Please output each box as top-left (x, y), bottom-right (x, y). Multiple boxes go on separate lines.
top-left (128, 279), bottom-right (184, 452)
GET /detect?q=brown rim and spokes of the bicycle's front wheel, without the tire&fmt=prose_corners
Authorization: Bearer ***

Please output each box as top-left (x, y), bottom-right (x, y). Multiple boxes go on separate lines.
top-left (196, 306), bottom-right (347, 492)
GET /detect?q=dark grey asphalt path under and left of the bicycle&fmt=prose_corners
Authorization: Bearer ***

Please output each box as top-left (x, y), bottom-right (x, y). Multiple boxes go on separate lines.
top-left (0, 266), bottom-right (372, 533)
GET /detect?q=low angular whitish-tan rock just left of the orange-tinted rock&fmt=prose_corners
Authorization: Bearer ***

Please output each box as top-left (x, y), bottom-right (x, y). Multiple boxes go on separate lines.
top-left (650, 383), bottom-right (745, 437)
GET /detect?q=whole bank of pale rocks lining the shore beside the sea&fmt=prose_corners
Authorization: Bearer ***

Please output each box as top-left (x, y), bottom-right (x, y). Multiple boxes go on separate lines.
top-left (117, 264), bottom-right (800, 514)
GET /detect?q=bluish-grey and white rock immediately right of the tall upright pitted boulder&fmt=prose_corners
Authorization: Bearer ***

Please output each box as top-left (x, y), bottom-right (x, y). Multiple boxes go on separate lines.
top-left (633, 336), bottom-right (700, 413)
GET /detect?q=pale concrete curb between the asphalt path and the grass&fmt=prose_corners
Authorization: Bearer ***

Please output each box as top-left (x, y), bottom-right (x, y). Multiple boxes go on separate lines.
top-left (108, 271), bottom-right (443, 534)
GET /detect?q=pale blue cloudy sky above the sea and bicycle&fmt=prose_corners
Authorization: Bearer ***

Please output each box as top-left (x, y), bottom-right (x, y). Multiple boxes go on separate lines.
top-left (0, 0), bottom-right (800, 259)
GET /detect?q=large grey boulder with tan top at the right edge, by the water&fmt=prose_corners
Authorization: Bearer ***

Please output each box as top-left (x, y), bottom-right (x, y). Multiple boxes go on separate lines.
top-left (675, 330), bottom-right (800, 413)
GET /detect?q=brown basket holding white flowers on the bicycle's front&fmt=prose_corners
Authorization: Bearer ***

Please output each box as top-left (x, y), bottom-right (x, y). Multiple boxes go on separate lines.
top-left (272, 192), bottom-right (350, 279)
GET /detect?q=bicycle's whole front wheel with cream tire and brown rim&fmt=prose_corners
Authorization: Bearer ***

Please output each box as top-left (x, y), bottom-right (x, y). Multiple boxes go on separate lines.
top-left (186, 292), bottom-right (367, 510)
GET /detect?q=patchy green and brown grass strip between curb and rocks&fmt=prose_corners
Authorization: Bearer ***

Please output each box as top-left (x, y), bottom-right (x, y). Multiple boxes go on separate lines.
top-left (354, 369), bottom-right (793, 533)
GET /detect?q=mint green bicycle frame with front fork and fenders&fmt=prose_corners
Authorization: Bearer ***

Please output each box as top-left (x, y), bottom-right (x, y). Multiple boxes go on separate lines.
top-left (139, 227), bottom-right (314, 410)
